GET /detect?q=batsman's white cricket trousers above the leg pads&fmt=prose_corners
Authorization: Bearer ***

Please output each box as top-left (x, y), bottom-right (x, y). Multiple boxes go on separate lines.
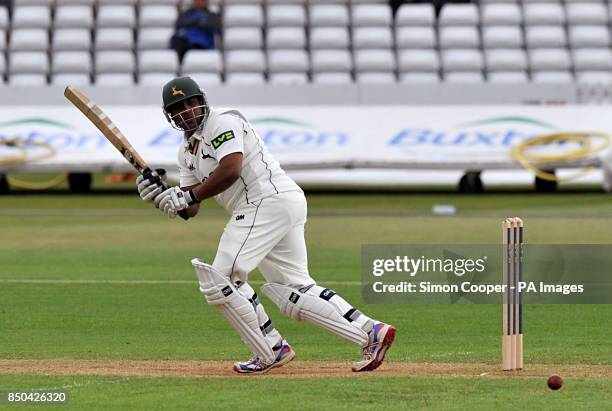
top-left (213, 191), bottom-right (315, 288)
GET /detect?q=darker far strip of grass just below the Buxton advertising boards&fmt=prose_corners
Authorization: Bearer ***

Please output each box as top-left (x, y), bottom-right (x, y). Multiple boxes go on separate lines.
top-left (0, 190), bottom-right (612, 216)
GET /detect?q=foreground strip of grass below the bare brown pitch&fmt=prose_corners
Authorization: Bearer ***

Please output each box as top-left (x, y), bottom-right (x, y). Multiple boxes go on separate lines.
top-left (0, 375), bottom-right (612, 411)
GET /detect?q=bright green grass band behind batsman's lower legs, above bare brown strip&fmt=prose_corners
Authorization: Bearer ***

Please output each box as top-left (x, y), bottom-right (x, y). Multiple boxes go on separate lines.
top-left (0, 281), bottom-right (612, 364)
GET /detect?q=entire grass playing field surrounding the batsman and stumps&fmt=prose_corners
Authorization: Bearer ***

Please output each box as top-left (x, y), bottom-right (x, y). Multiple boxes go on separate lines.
top-left (0, 193), bottom-right (612, 409)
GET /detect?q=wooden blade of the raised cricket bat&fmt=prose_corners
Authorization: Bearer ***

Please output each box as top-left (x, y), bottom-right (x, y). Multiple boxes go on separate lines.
top-left (64, 86), bottom-right (149, 173)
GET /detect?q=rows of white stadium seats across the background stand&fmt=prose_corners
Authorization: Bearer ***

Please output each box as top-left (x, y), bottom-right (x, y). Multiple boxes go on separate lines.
top-left (0, 0), bottom-right (612, 85)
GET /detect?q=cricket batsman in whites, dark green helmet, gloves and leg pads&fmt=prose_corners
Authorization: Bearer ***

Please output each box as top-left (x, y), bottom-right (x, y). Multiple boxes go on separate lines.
top-left (136, 77), bottom-right (395, 374)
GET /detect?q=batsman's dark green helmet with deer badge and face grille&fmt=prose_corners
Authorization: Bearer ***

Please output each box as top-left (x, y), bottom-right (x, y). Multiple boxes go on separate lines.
top-left (162, 76), bottom-right (209, 131)
